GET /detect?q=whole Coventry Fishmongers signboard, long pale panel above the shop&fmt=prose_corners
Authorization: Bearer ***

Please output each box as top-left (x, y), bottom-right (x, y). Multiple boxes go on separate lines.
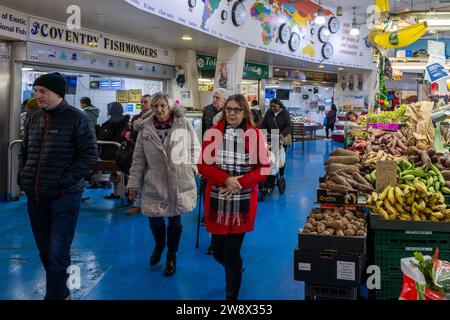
top-left (29, 18), bottom-right (175, 65)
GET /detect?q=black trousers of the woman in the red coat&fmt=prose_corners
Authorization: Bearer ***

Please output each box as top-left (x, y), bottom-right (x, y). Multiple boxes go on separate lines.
top-left (211, 233), bottom-right (245, 300)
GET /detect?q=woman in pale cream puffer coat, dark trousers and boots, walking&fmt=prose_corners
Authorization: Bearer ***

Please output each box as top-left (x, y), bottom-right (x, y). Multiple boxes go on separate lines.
top-left (128, 92), bottom-right (200, 276)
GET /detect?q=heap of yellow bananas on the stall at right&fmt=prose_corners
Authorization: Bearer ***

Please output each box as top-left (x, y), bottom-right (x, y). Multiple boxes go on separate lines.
top-left (367, 181), bottom-right (450, 222)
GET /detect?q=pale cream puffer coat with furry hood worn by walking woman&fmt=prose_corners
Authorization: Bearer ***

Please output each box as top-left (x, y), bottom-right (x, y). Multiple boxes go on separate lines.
top-left (127, 106), bottom-right (200, 217)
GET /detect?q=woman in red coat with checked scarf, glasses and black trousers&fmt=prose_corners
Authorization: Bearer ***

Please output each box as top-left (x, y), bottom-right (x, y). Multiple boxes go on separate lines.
top-left (198, 94), bottom-right (270, 300)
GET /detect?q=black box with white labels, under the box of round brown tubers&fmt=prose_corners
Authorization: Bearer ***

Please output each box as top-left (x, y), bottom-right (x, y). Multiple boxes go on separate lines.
top-left (294, 247), bottom-right (367, 286)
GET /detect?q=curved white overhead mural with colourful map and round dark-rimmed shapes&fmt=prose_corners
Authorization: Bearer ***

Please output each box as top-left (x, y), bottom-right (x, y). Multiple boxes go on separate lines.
top-left (125, 0), bottom-right (374, 69)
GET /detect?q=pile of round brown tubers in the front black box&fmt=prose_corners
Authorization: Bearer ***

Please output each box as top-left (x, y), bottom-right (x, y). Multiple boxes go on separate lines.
top-left (302, 208), bottom-right (367, 237)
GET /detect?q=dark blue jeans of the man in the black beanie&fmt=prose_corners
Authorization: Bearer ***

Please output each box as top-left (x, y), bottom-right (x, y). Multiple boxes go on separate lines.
top-left (28, 192), bottom-right (82, 300)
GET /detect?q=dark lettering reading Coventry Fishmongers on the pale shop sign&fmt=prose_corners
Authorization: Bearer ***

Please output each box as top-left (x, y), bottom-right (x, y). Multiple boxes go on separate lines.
top-left (31, 22), bottom-right (158, 58)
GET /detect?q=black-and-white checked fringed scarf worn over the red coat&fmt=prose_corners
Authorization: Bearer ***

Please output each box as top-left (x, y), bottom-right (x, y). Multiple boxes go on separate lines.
top-left (210, 121), bottom-right (252, 227)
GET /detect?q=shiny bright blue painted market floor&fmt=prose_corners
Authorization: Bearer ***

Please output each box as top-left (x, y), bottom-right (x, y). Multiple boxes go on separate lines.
top-left (0, 141), bottom-right (340, 300)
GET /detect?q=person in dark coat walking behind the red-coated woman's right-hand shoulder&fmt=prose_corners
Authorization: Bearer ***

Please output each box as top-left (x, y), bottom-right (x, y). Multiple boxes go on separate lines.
top-left (259, 98), bottom-right (292, 177)
